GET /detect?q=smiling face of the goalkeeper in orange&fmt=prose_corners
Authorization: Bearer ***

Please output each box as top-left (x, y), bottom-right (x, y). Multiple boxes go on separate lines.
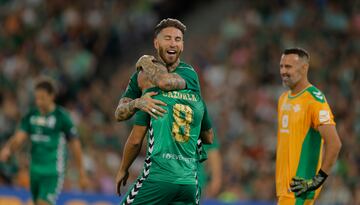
top-left (280, 54), bottom-right (308, 90)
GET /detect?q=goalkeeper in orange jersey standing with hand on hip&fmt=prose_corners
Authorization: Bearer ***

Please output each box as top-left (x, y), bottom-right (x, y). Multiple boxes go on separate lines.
top-left (276, 48), bottom-right (341, 205)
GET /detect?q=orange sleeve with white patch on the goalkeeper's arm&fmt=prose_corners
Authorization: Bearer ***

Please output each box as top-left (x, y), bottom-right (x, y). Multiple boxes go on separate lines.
top-left (310, 98), bottom-right (335, 129)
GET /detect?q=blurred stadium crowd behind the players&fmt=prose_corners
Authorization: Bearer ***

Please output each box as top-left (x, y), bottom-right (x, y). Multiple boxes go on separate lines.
top-left (0, 0), bottom-right (360, 205)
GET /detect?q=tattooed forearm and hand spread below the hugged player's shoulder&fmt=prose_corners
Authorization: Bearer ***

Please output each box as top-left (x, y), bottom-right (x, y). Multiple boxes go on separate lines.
top-left (115, 92), bottom-right (166, 121)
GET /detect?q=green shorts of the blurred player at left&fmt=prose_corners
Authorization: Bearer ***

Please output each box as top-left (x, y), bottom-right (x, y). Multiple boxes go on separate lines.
top-left (30, 173), bottom-right (64, 204)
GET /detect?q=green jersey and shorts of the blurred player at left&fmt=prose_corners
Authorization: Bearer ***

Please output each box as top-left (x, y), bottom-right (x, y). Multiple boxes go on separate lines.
top-left (19, 106), bottom-right (77, 204)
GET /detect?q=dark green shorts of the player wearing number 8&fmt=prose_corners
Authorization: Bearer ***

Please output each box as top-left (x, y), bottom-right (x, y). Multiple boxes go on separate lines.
top-left (120, 178), bottom-right (198, 205)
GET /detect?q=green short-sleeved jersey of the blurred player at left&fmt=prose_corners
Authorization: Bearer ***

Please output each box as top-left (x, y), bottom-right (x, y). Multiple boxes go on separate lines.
top-left (20, 106), bottom-right (77, 175)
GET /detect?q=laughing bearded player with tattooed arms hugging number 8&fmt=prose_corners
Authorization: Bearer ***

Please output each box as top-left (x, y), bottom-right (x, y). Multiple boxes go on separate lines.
top-left (115, 18), bottom-right (210, 126)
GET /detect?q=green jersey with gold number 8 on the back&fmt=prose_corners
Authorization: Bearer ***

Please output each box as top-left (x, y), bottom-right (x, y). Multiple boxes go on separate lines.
top-left (135, 88), bottom-right (206, 184)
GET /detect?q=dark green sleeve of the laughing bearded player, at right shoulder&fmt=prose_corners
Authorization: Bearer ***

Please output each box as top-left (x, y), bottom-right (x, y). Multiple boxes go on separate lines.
top-left (175, 67), bottom-right (200, 94)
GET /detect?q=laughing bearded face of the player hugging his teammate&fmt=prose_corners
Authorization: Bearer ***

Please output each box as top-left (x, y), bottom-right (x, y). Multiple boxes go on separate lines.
top-left (154, 27), bottom-right (184, 67)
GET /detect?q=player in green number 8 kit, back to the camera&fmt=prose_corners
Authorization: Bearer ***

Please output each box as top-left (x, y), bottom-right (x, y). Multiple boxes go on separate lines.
top-left (116, 58), bottom-right (213, 205)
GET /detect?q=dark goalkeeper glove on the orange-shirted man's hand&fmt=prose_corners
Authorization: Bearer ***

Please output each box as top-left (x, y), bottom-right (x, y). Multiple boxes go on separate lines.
top-left (290, 169), bottom-right (328, 196)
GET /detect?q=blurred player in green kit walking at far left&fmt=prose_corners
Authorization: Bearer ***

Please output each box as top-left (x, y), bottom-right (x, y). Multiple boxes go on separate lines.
top-left (0, 78), bottom-right (88, 205)
